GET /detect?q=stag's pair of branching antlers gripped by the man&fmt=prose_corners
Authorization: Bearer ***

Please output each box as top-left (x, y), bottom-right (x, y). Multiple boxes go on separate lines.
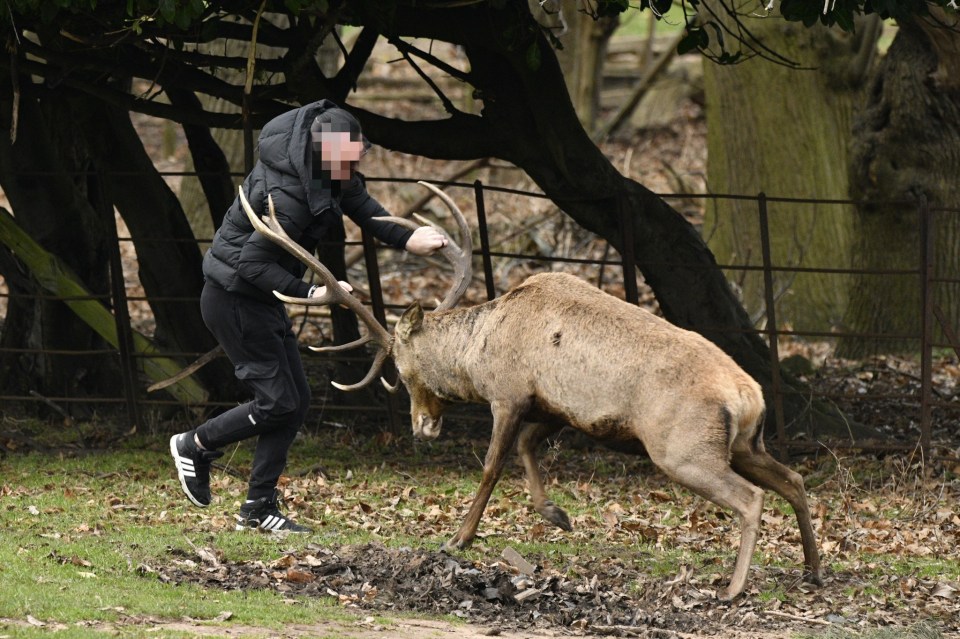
top-left (240, 182), bottom-right (473, 391)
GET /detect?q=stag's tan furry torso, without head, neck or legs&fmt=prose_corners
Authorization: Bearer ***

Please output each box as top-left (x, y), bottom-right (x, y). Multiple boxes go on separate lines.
top-left (465, 273), bottom-right (763, 443)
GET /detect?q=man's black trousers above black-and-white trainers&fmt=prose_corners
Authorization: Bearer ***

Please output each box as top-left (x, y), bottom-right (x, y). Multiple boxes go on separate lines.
top-left (196, 283), bottom-right (310, 499)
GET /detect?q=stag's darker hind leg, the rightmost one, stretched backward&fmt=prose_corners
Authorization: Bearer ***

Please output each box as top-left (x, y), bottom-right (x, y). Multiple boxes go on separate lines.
top-left (731, 445), bottom-right (823, 585)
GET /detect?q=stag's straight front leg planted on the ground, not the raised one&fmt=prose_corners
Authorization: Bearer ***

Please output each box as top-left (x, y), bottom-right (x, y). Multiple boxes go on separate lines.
top-left (441, 400), bottom-right (529, 550)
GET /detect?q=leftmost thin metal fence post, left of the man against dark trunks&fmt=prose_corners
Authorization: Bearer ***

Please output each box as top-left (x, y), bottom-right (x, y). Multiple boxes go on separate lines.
top-left (97, 171), bottom-right (140, 428)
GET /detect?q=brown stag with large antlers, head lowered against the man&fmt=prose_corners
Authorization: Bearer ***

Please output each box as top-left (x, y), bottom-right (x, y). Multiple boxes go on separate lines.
top-left (241, 182), bottom-right (820, 600)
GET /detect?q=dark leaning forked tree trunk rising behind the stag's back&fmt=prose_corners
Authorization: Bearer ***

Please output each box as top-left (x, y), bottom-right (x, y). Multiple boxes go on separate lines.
top-left (365, 6), bottom-right (863, 436)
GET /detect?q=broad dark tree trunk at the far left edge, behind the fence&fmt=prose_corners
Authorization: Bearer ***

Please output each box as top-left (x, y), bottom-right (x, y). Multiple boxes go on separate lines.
top-left (0, 84), bottom-right (119, 402)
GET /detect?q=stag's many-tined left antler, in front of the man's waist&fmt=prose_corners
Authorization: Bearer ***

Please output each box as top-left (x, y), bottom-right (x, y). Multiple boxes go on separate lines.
top-left (239, 186), bottom-right (393, 390)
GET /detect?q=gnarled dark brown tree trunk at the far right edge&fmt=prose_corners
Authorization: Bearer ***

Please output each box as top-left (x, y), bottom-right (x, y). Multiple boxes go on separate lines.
top-left (838, 14), bottom-right (960, 357)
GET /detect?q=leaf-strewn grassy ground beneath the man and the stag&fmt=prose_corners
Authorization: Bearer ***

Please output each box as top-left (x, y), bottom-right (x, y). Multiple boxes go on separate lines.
top-left (0, 418), bottom-right (960, 639)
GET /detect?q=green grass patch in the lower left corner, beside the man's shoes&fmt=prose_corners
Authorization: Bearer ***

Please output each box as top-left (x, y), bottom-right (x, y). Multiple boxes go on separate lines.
top-left (0, 451), bottom-right (342, 627)
